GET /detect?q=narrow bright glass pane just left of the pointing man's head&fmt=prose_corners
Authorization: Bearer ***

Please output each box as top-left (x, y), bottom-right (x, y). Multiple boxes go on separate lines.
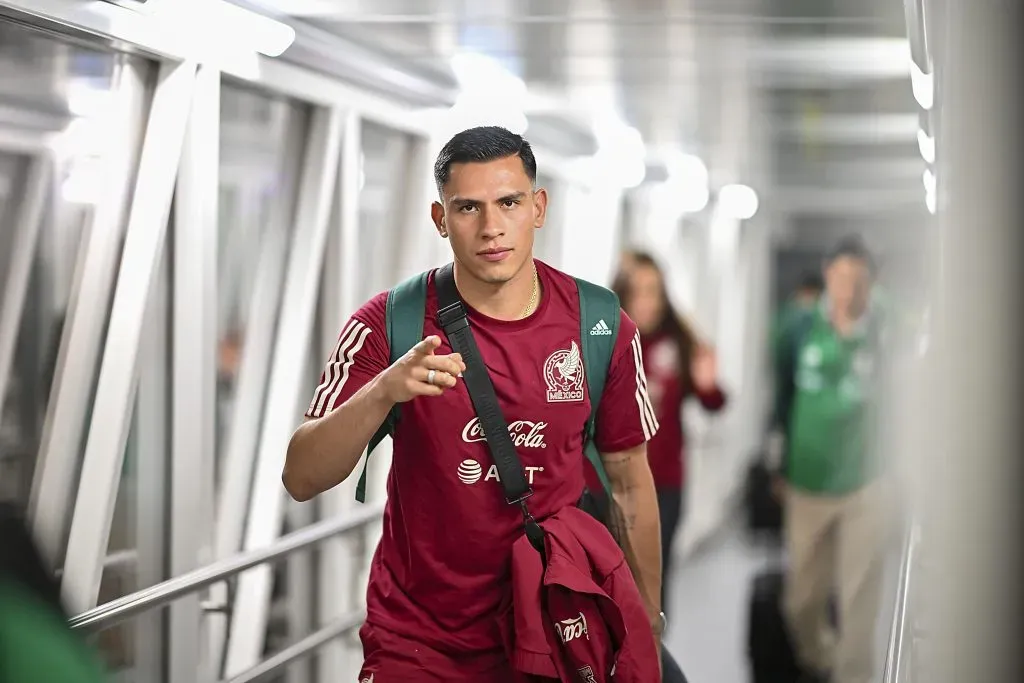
top-left (358, 122), bottom-right (412, 304)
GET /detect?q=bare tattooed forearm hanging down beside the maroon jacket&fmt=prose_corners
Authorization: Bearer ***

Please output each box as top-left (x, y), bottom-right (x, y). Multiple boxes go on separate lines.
top-left (605, 454), bottom-right (663, 625)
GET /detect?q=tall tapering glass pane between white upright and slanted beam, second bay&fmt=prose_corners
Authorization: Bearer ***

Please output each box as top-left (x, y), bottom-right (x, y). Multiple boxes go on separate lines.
top-left (216, 81), bottom-right (309, 489)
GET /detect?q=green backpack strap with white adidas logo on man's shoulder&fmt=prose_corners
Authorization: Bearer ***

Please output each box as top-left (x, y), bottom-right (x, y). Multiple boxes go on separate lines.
top-left (577, 279), bottom-right (620, 496)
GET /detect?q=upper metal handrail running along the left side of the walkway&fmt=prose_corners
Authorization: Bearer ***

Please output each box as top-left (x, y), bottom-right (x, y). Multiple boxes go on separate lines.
top-left (70, 504), bottom-right (384, 631)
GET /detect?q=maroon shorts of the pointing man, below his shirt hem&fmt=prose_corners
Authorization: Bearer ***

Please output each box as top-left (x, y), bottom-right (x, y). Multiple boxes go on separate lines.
top-left (358, 624), bottom-right (538, 683)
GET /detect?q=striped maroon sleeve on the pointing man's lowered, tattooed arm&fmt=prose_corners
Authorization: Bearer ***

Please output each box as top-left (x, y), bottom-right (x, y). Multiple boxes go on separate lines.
top-left (594, 311), bottom-right (658, 453)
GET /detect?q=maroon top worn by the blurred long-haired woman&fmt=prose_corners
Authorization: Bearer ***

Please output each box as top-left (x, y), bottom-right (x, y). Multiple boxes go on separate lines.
top-left (587, 335), bottom-right (726, 492)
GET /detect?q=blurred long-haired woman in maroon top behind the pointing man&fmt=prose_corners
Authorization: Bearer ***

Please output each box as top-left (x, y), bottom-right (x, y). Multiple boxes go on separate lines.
top-left (588, 252), bottom-right (726, 611)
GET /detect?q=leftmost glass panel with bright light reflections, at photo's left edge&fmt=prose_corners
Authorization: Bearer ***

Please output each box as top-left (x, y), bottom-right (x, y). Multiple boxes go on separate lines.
top-left (0, 23), bottom-right (143, 516)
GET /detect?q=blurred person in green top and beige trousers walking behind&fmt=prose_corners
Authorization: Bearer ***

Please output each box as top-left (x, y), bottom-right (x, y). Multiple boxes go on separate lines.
top-left (773, 238), bottom-right (890, 683)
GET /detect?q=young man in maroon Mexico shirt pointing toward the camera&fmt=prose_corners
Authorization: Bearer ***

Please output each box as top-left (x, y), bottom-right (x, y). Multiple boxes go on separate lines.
top-left (283, 127), bottom-right (662, 683)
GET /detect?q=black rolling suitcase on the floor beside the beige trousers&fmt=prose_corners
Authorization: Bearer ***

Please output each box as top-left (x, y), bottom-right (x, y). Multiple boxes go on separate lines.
top-left (748, 568), bottom-right (801, 683)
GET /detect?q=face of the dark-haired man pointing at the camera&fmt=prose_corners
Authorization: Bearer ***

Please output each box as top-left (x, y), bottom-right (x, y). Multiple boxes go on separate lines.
top-left (431, 156), bottom-right (548, 284)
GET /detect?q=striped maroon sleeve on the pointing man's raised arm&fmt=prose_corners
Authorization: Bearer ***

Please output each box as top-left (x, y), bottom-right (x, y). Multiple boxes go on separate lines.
top-left (306, 292), bottom-right (391, 418)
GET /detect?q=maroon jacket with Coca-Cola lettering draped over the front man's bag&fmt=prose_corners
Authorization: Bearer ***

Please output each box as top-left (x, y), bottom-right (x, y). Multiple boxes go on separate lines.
top-left (500, 507), bottom-right (659, 683)
